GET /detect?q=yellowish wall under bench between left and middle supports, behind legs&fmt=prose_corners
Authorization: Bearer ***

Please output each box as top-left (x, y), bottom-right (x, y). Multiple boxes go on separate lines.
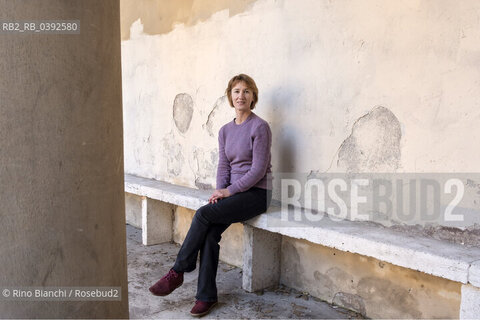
top-left (173, 207), bottom-right (243, 268)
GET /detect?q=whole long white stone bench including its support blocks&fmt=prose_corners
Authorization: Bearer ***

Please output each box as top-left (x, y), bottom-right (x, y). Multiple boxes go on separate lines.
top-left (125, 175), bottom-right (480, 319)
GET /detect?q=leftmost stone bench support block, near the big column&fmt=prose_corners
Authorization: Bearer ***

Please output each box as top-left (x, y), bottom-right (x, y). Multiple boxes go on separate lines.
top-left (142, 197), bottom-right (174, 246)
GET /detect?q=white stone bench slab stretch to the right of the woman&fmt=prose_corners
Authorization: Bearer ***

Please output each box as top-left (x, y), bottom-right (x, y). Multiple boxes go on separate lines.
top-left (248, 211), bottom-right (480, 284)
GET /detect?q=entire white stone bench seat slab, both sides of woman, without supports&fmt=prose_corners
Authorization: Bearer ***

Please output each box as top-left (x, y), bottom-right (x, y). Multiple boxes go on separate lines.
top-left (125, 175), bottom-right (480, 286)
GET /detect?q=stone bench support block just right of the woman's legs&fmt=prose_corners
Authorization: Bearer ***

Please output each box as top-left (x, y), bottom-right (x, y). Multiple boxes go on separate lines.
top-left (242, 224), bottom-right (282, 292)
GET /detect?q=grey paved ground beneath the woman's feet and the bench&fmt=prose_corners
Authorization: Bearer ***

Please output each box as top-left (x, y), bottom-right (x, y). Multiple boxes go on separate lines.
top-left (127, 226), bottom-right (361, 319)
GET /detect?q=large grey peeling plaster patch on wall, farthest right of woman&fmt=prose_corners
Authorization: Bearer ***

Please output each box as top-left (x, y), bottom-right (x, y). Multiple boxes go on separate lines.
top-left (337, 106), bottom-right (402, 172)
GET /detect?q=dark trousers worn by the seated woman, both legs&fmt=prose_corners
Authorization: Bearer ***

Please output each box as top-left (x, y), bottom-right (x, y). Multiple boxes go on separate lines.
top-left (173, 187), bottom-right (272, 301)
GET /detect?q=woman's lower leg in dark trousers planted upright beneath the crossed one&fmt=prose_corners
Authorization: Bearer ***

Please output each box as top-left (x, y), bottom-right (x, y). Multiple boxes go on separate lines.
top-left (196, 224), bottom-right (229, 301)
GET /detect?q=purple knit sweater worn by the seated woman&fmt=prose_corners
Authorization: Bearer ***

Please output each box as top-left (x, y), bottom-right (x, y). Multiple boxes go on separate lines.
top-left (217, 112), bottom-right (272, 195)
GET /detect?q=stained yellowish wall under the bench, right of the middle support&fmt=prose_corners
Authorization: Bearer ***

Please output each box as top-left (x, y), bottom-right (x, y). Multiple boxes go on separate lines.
top-left (280, 237), bottom-right (461, 319)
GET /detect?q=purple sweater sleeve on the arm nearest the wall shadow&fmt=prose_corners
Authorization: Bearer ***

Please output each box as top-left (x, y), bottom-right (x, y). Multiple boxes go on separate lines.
top-left (227, 123), bottom-right (272, 195)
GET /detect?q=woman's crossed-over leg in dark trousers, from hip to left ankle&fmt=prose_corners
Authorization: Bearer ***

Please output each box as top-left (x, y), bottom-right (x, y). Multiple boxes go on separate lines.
top-left (173, 188), bottom-right (271, 272)
